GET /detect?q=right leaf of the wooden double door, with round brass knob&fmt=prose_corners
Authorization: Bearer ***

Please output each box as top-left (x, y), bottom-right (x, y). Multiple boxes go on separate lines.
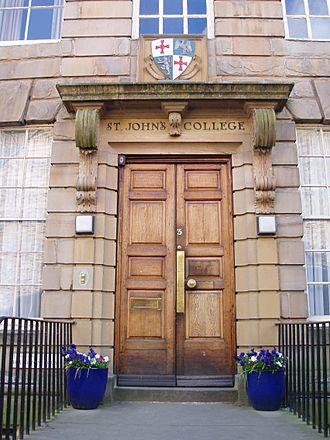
top-left (176, 164), bottom-right (233, 376)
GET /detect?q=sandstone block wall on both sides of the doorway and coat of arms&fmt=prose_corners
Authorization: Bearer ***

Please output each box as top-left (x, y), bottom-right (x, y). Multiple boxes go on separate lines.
top-left (0, 0), bottom-right (330, 351)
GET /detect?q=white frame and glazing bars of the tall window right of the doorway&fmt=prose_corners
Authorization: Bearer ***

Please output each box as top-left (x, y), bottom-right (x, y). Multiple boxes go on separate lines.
top-left (297, 125), bottom-right (330, 321)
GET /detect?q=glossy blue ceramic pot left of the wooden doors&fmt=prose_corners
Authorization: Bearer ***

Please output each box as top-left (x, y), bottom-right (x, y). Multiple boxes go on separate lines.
top-left (66, 367), bottom-right (108, 409)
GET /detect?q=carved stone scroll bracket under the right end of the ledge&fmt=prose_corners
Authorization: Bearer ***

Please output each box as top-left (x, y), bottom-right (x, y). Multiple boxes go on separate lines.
top-left (249, 106), bottom-right (276, 214)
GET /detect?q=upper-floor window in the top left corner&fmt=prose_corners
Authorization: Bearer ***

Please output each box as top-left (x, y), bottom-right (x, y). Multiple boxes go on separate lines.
top-left (0, 0), bottom-right (64, 41)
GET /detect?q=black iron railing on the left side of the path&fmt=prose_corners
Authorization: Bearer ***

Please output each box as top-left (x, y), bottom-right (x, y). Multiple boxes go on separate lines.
top-left (0, 316), bottom-right (73, 440)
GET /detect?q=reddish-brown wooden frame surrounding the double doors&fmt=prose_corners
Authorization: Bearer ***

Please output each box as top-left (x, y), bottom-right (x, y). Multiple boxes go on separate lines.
top-left (113, 153), bottom-right (236, 382)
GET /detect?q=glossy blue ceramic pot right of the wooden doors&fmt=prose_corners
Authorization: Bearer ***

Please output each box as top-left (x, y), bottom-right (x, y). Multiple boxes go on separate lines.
top-left (246, 371), bottom-right (285, 411)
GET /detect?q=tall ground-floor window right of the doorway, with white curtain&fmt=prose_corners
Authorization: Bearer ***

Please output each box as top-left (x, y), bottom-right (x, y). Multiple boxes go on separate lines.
top-left (297, 128), bottom-right (330, 316)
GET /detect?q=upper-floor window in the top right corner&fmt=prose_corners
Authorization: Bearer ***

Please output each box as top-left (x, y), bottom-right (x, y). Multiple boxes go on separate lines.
top-left (283, 0), bottom-right (330, 40)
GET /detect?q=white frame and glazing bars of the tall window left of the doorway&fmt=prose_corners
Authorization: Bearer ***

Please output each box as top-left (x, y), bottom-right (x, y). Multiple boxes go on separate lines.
top-left (0, 124), bottom-right (54, 318)
